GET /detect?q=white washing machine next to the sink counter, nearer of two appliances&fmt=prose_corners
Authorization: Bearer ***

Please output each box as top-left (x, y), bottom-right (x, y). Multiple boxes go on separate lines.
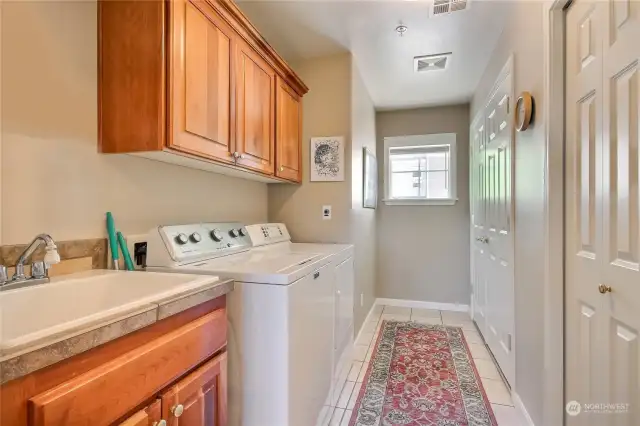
top-left (147, 223), bottom-right (334, 426)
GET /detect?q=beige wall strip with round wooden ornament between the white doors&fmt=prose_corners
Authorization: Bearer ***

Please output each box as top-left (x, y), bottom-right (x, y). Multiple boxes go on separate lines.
top-left (472, 2), bottom-right (546, 425)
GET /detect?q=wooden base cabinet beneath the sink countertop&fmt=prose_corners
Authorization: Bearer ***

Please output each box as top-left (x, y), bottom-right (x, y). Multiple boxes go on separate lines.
top-left (0, 298), bottom-right (227, 426)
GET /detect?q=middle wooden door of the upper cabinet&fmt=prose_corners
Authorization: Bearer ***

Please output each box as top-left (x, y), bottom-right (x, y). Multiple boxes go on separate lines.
top-left (236, 43), bottom-right (276, 174)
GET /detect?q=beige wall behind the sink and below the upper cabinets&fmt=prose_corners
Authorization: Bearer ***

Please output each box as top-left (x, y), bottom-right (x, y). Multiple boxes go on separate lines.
top-left (1, 1), bottom-right (268, 244)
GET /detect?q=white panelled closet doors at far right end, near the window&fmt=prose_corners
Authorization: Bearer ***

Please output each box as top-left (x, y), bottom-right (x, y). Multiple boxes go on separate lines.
top-left (471, 62), bottom-right (515, 384)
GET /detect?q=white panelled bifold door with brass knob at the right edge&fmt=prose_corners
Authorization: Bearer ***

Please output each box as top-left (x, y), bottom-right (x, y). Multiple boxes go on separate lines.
top-left (565, 0), bottom-right (640, 426)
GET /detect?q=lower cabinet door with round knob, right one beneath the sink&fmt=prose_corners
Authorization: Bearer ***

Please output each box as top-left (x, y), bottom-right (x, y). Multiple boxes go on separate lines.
top-left (161, 352), bottom-right (227, 426)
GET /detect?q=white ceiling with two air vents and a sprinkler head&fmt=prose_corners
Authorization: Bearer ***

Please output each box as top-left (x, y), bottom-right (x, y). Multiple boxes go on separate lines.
top-left (238, 0), bottom-right (509, 110)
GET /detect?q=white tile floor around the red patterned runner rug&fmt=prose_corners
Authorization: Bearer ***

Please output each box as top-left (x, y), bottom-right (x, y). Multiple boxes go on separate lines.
top-left (324, 305), bottom-right (525, 426)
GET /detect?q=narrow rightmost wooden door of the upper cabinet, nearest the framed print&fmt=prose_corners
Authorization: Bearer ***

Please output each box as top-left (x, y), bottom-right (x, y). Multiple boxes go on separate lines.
top-left (276, 77), bottom-right (302, 182)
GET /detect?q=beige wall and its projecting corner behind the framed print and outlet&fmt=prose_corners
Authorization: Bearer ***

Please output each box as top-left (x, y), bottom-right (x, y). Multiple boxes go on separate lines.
top-left (269, 54), bottom-right (376, 332)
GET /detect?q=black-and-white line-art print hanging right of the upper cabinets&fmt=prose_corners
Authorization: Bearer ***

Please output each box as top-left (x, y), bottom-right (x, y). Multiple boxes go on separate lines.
top-left (309, 136), bottom-right (345, 182)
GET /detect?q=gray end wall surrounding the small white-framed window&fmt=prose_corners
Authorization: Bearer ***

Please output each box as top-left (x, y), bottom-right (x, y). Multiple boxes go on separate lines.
top-left (376, 105), bottom-right (470, 304)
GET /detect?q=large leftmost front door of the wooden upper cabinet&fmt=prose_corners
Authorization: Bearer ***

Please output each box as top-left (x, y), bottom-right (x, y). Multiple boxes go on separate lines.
top-left (169, 0), bottom-right (234, 163)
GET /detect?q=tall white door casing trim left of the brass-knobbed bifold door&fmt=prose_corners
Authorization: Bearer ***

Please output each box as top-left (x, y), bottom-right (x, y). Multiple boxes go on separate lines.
top-left (542, 0), bottom-right (571, 425)
